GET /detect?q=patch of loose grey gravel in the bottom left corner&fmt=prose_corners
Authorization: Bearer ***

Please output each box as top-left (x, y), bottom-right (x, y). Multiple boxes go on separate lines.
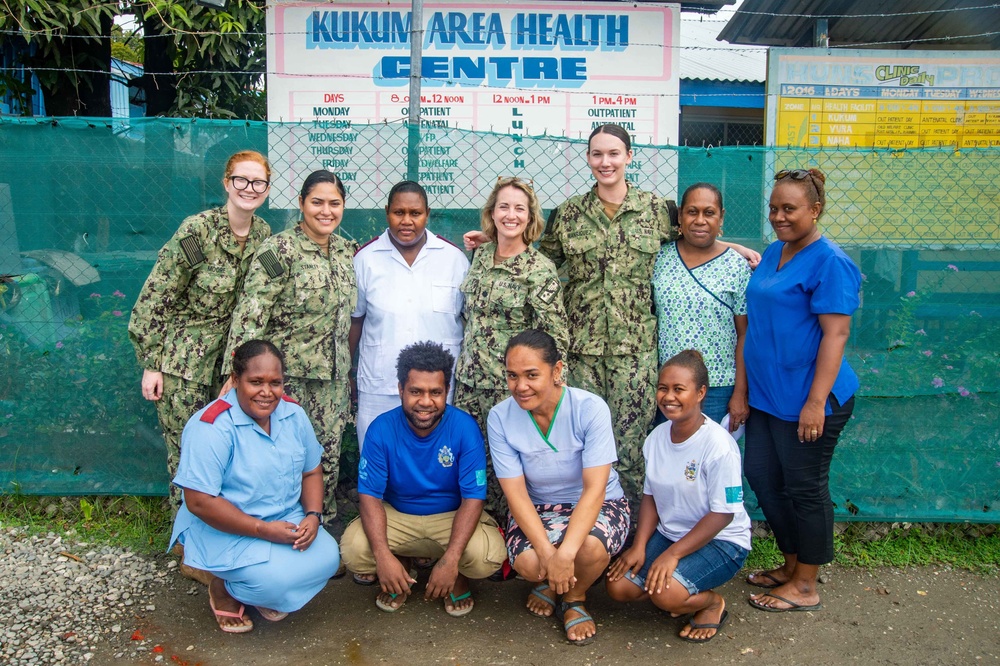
top-left (0, 528), bottom-right (170, 666)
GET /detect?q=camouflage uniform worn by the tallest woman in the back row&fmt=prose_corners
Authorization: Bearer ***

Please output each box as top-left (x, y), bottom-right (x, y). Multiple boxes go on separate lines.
top-left (539, 183), bottom-right (676, 503)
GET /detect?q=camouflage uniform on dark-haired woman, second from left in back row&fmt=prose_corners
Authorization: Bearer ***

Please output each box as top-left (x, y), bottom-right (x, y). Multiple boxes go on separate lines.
top-left (223, 227), bottom-right (358, 520)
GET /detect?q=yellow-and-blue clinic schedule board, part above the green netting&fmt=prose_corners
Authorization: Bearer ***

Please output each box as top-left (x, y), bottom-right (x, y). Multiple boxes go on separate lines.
top-left (768, 49), bottom-right (1000, 148)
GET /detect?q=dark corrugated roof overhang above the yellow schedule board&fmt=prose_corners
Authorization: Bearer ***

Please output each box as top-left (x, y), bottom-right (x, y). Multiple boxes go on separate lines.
top-left (719, 0), bottom-right (1000, 49)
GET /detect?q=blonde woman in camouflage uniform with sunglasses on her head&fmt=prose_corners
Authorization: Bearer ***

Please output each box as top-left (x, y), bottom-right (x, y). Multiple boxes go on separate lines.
top-left (455, 178), bottom-right (569, 515)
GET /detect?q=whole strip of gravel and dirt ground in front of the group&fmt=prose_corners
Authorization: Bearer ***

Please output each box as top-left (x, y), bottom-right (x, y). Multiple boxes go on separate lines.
top-left (0, 527), bottom-right (1000, 666)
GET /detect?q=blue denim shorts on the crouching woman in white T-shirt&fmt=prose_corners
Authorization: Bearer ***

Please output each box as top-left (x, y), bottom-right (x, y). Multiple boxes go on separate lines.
top-left (625, 530), bottom-right (750, 594)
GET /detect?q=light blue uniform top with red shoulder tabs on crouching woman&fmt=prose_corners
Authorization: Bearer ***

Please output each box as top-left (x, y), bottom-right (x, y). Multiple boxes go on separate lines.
top-left (170, 389), bottom-right (322, 571)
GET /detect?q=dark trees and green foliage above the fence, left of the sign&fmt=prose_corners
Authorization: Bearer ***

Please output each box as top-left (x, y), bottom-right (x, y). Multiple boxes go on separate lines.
top-left (0, 0), bottom-right (266, 119)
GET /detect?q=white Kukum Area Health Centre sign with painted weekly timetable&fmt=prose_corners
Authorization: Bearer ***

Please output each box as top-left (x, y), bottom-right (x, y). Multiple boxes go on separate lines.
top-left (267, 0), bottom-right (680, 208)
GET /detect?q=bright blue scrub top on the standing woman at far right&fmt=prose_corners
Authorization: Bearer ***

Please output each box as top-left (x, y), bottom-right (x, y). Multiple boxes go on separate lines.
top-left (743, 236), bottom-right (861, 422)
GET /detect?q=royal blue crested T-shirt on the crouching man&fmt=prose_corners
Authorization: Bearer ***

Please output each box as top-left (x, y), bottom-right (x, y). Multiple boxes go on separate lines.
top-left (358, 405), bottom-right (486, 516)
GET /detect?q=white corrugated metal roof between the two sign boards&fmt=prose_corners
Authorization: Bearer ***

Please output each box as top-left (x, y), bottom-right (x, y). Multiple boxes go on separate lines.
top-left (680, 15), bottom-right (767, 82)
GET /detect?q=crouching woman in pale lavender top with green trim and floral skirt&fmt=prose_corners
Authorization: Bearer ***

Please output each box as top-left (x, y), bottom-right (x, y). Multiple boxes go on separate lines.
top-left (487, 330), bottom-right (629, 645)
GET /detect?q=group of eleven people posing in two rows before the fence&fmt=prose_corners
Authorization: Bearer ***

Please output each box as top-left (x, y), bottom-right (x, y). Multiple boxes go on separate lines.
top-left (129, 125), bottom-right (860, 644)
